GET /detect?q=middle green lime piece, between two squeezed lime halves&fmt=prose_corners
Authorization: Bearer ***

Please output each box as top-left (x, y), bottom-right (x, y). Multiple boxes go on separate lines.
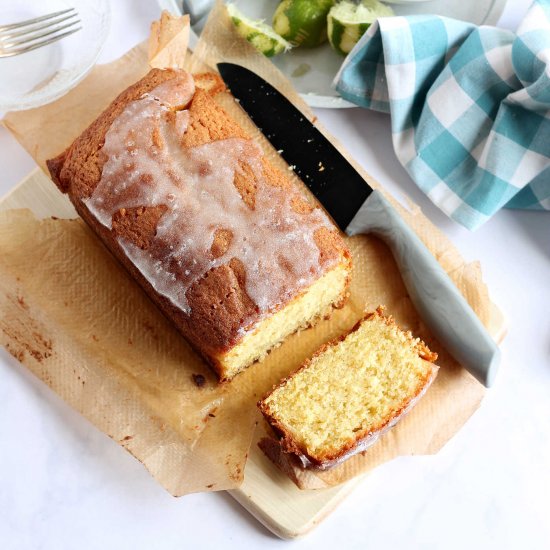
top-left (273, 0), bottom-right (334, 47)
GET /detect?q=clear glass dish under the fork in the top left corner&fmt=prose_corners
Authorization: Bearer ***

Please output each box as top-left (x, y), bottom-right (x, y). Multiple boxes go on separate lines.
top-left (0, 0), bottom-right (110, 113)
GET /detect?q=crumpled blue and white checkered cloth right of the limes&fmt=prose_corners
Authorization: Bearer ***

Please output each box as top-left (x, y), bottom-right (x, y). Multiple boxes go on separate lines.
top-left (336, 0), bottom-right (550, 229)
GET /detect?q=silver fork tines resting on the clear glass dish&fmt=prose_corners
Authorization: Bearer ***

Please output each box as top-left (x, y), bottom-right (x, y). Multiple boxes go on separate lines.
top-left (0, 8), bottom-right (82, 58)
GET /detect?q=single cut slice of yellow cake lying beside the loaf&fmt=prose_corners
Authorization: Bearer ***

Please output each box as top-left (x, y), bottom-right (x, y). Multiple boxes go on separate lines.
top-left (258, 307), bottom-right (438, 469)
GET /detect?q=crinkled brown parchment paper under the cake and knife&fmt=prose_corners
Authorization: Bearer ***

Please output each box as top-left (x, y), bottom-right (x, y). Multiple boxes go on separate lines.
top-left (0, 3), bottom-right (490, 495)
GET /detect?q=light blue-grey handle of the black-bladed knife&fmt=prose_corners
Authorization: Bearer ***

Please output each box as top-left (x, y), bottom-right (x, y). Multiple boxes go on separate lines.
top-left (346, 190), bottom-right (500, 387)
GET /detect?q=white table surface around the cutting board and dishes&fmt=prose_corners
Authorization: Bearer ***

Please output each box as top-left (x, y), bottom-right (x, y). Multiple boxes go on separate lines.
top-left (0, 0), bottom-right (550, 550)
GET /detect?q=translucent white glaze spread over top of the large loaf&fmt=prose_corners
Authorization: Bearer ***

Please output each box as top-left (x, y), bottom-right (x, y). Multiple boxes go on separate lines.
top-left (85, 77), bottom-right (333, 316)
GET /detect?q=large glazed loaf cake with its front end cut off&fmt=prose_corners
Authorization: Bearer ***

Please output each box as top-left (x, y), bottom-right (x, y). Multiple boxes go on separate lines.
top-left (48, 69), bottom-right (351, 380)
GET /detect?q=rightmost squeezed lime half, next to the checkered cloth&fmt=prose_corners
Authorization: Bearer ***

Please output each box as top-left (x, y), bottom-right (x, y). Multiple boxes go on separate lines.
top-left (327, 0), bottom-right (395, 55)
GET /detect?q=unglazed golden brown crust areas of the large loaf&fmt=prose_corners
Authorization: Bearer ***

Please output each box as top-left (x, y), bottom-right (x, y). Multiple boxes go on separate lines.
top-left (47, 69), bottom-right (350, 374)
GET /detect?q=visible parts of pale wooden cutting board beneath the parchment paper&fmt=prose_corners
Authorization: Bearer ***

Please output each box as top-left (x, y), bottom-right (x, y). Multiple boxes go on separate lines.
top-left (0, 168), bottom-right (506, 538)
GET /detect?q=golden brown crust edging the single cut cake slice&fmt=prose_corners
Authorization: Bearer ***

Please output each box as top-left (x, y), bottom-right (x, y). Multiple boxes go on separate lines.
top-left (257, 306), bottom-right (439, 471)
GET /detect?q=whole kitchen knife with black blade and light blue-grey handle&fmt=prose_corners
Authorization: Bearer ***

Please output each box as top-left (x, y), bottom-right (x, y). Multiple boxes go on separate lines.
top-left (218, 63), bottom-right (500, 387)
